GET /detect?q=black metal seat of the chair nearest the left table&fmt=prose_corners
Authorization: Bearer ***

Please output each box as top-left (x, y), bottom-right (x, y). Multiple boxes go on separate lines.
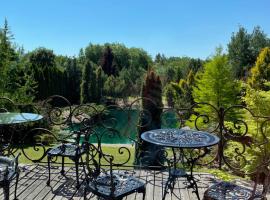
top-left (48, 143), bottom-right (86, 157)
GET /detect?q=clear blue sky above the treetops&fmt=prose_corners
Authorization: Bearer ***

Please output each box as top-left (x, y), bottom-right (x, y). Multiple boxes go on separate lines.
top-left (0, 0), bottom-right (270, 59)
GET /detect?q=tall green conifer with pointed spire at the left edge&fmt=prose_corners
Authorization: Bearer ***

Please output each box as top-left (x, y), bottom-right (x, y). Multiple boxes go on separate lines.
top-left (0, 20), bottom-right (35, 103)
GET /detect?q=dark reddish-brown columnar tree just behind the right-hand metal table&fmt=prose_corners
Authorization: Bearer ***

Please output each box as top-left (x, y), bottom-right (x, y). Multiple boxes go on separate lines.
top-left (136, 71), bottom-right (163, 166)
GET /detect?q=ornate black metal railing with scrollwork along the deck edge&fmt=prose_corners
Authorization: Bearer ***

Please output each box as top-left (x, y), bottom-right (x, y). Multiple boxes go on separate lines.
top-left (0, 95), bottom-right (270, 179)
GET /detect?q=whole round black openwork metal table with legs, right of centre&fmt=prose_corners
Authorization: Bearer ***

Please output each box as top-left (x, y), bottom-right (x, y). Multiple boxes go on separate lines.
top-left (141, 129), bottom-right (220, 199)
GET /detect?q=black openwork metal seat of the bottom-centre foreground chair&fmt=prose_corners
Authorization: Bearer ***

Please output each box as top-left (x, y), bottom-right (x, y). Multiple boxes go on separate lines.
top-left (88, 173), bottom-right (145, 199)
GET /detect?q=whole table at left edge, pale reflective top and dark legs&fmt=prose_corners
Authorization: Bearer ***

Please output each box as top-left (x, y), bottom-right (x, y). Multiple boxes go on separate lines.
top-left (0, 112), bottom-right (43, 155)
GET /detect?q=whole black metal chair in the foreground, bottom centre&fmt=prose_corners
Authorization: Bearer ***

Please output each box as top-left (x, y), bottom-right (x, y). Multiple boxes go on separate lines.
top-left (84, 139), bottom-right (146, 200)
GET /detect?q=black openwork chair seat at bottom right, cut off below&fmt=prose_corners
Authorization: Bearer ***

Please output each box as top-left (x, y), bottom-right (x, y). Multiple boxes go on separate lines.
top-left (204, 182), bottom-right (262, 200)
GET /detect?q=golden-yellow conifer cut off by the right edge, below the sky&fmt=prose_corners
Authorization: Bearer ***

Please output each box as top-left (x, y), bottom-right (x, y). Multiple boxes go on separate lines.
top-left (248, 47), bottom-right (270, 90)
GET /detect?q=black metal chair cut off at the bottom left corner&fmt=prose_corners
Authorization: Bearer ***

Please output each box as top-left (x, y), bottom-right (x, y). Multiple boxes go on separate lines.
top-left (0, 154), bottom-right (20, 200)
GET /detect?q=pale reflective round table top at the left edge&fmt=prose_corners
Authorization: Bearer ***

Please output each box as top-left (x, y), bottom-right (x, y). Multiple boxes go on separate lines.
top-left (0, 112), bottom-right (43, 125)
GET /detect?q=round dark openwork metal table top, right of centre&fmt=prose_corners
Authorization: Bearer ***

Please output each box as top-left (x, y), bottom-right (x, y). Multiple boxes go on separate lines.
top-left (141, 129), bottom-right (220, 148)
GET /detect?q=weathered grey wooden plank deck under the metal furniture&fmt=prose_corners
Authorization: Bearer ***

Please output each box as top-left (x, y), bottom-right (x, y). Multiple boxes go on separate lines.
top-left (0, 165), bottom-right (266, 200)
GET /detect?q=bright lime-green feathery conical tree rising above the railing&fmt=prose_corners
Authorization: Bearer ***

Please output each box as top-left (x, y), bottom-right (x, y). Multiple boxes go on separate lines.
top-left (192, 49), bottom-right (239, 113)
